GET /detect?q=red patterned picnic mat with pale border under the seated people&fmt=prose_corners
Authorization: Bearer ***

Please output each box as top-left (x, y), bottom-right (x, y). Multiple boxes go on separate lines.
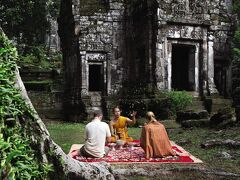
top-left (75, 140), bottom-right (202, 163)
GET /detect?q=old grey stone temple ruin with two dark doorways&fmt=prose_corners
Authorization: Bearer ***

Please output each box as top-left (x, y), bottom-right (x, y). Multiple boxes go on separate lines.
top-left (65, 0), bottom-right (231, 111)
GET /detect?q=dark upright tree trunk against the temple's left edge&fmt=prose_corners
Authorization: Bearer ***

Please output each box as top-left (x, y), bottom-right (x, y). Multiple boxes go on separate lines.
top-left (58, 0), bottom-right (86, 121)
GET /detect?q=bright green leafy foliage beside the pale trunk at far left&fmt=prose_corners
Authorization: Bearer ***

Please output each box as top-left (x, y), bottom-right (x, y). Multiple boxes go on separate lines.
top-left (0, 31), bottom-right (52, 179)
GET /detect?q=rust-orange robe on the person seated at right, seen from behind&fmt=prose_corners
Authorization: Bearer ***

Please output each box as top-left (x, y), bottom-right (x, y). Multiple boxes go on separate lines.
top-left (140, 121), bottom-right (176, 158)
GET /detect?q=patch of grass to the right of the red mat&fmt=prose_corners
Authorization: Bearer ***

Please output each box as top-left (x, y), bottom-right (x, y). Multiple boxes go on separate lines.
top-left (169, 127), bottom-right (240, 174)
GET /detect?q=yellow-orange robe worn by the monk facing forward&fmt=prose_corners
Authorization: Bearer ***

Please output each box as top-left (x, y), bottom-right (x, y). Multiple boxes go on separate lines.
top-left (111, 116), bottom-right (133, 142)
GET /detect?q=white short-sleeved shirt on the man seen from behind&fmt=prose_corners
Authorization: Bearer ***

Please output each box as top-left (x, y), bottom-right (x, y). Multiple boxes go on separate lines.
top-left (84, 118), bottom-right (111, 157)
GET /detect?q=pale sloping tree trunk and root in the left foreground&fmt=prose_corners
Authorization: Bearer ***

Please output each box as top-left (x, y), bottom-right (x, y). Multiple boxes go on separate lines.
top-left (16, 70), bottom-right (114, 180)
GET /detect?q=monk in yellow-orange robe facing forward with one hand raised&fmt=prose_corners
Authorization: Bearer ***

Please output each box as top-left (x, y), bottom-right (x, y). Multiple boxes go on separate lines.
top-left (109, 106), bottom-right (136, 142)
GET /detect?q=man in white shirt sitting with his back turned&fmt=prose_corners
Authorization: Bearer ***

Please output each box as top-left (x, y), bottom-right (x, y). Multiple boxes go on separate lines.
top-left (78, 110), bottom-right (111, 158)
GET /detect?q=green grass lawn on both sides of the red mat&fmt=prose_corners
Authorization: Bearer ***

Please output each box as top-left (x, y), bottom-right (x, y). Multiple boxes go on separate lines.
top-left (46, 121), bottom-right (240, 174)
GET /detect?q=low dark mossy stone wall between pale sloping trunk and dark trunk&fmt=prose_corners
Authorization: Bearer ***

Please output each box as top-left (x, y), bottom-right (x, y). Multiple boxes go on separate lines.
top-left (20, 70), bottom-right (64, 120)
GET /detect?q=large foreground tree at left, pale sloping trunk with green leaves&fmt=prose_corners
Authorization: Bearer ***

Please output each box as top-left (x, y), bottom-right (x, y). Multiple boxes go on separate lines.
top-left (0, 29), bottom-right (114, 179)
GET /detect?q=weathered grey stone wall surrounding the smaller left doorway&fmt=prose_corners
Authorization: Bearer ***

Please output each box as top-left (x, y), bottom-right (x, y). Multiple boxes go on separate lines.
top-left (73, 0), bottom-right (125, 96)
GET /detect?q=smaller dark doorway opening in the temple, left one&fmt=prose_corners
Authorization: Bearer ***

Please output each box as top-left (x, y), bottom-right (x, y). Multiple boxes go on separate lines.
top-left (89, 64), bottom-right (103, 91)
